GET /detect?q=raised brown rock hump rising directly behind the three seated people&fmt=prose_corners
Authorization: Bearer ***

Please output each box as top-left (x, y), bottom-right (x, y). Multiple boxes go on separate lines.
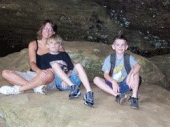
top-left (0, 41), bottom-right (168, 88)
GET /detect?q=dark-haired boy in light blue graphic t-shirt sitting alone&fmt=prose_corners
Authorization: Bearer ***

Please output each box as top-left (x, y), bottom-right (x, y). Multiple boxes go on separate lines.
top-left (93, 33), bottom-right (140, 109)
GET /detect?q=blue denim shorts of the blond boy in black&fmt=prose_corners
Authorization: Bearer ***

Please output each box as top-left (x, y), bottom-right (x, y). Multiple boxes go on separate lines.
top-left (55, 69), bottom-right (81, 91)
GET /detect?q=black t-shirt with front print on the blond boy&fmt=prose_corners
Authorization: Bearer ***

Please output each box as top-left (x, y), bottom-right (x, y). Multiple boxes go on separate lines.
top-left (41, 52), bottom-right (74, 73)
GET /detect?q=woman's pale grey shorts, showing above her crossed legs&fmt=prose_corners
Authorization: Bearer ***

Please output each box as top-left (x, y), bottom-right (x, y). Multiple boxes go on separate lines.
top-left (15, 71), bottom-right (56, 90)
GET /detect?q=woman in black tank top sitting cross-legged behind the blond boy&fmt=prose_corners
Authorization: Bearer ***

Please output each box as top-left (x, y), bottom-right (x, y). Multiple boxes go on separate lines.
top-left (0, 20), bottom-right (65, 95)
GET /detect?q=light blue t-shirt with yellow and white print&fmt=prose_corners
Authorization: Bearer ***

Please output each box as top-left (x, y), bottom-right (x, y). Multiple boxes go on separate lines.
top-left (102, 55), bottom-right (137, 82)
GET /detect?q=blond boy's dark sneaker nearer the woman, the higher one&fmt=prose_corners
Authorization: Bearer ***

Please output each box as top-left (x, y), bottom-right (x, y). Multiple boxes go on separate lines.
top-left (69, 85), bottom-right (81, 99)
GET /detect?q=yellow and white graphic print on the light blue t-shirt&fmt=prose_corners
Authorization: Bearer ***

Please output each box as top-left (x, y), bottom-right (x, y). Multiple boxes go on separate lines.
top-left (112, 64), bottom-right (125, 82)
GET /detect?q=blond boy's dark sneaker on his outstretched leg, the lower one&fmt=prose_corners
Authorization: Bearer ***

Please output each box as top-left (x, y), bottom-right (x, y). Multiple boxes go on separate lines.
top-left (84, 91), bottom-right (94, 107)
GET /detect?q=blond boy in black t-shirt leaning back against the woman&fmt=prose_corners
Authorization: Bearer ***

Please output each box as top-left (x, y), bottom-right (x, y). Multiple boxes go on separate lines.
top-left (41, 35), bottom-right (94, 106)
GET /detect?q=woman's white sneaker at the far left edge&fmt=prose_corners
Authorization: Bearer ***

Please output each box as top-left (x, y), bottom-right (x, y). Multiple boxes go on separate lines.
top-left (0, 86), bottom-right (21, 95)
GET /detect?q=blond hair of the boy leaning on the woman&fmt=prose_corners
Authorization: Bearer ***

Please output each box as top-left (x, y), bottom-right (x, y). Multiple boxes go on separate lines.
top-left (47, 34), bottom-right (63, 45)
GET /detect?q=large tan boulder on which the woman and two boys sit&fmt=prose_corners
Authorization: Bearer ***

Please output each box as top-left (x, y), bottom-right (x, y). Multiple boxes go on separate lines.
top-left (0, 42), bottom-right (170, 127)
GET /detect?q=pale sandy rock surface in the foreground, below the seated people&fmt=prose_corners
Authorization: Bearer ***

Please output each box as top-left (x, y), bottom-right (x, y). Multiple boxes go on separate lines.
top-left (0, 84), bottom-right (170, 127)
